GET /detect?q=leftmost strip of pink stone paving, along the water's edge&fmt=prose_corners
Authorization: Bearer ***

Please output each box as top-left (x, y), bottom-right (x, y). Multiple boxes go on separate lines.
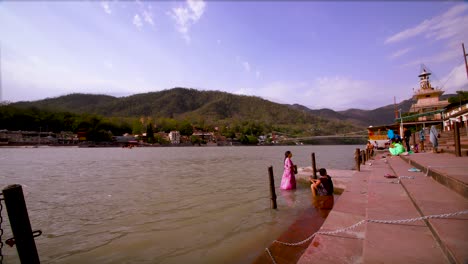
top-left (298, 170), bottom-right (370, 264)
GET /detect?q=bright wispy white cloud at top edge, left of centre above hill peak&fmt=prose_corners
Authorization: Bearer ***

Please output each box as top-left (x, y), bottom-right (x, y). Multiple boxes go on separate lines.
top-left (168, 0), bottom-right (206, 43)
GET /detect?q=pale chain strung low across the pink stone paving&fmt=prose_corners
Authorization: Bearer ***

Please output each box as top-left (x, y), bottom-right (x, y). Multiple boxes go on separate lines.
top-left (266, 210), bottom-right (468, 264)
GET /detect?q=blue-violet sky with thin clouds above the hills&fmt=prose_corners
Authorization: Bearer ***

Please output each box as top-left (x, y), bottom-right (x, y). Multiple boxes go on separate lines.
top-left (0, 1), bottom-right (468, 110)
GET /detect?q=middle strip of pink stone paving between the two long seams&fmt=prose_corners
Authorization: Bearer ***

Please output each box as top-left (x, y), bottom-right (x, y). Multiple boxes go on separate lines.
top-left (363, 158), bottom-right (447, 263)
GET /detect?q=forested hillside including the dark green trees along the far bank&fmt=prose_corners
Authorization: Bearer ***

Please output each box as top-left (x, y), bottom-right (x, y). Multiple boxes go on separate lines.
top-left (0, 88), bottom-right (363, 143)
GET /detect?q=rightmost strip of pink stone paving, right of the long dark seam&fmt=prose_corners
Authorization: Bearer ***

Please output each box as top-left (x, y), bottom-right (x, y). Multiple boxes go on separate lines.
top-left (389, 157), bottom-right (468, 263)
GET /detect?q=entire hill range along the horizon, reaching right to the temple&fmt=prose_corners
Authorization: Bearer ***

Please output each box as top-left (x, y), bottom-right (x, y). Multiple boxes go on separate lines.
top-left (11, 88), bottom-right (449, 129)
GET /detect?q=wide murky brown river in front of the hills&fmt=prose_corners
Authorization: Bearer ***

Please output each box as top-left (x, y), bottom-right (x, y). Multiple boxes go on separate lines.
top-left (0, 145), bottom-right (362, 264)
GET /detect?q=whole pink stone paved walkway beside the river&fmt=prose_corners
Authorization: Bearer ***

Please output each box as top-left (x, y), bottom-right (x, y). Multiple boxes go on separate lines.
top-left (290, 153), bottom-right (468, 263)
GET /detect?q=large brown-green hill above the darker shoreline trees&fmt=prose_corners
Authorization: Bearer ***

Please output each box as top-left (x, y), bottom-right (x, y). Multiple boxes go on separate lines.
top-left (10, 88), bottom-right (363, 135)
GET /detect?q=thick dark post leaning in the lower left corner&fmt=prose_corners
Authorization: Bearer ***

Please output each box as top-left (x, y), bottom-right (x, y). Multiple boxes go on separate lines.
top-left (3, 184), bottom-right (40, 264)
